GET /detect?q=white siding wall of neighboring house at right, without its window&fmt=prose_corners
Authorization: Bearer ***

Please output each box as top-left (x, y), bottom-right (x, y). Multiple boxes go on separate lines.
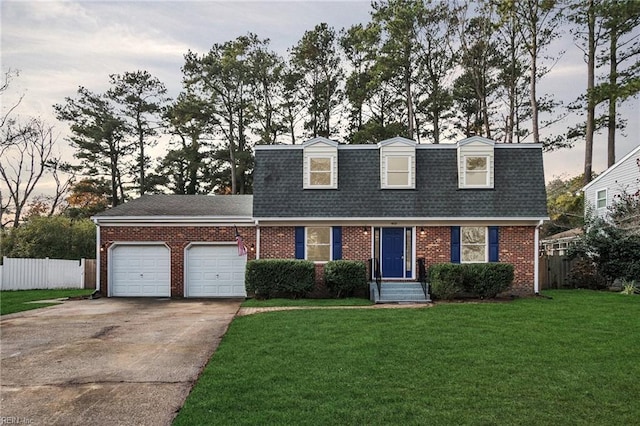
top-left (584, 150), bottom-right (640, 217)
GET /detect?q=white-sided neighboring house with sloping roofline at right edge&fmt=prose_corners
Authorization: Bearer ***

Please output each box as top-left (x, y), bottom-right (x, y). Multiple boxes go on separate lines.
top-left (582, 145), bottom-right (640, 218)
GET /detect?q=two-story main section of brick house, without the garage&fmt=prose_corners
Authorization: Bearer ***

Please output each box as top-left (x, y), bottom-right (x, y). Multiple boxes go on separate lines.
top-left (253, 137), bottom-right (547, 302)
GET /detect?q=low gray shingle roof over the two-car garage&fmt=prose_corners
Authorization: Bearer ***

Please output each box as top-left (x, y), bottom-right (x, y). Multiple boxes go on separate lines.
top-left (95, 195), bottom-right (253, 218)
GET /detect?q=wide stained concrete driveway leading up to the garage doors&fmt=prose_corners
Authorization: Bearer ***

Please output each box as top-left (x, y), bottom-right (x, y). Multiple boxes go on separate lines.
top-left (0, 299), bottom-right (240, 425)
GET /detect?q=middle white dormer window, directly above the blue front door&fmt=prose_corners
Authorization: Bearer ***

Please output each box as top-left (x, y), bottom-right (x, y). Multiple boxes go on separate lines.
top-left (378, 137), bottom-right (416, 189)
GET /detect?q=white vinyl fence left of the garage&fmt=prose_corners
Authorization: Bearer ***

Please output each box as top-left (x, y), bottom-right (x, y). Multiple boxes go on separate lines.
top-left (0, 257), bottom-right (85, 290)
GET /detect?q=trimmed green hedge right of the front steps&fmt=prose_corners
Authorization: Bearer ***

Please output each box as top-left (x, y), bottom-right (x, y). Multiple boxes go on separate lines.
top-left (429, 263), bottom-right (514, 299)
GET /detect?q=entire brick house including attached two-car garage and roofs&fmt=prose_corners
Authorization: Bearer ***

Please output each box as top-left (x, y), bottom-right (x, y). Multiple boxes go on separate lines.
top-left (94, 137), bottom-right (548, 301)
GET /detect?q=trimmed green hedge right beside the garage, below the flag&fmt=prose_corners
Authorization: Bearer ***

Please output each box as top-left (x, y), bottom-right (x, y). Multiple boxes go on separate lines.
top-left (245, 259), bottom-right (315, 299)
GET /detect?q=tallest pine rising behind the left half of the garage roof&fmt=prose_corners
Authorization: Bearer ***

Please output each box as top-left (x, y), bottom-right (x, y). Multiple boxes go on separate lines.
top-left (107, 71), bottom-right (168, 195)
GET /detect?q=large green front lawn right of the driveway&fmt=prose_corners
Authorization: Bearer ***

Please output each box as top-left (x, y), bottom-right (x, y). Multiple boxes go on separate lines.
top-left (174, 291), bottom-right (640, 426)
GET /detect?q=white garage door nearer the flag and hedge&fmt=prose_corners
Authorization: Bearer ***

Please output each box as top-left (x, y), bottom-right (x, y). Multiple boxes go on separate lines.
top-left (186, 245), bottom-right (247, 297)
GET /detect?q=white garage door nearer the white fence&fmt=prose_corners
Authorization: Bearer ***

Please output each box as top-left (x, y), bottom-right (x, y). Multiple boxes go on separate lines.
top-left (111, 245), bottom-right (171, 297)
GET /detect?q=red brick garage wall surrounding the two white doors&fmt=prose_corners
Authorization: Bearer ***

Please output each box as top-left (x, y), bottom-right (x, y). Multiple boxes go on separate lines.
top-left (100, 226), bottom-right (256, 297)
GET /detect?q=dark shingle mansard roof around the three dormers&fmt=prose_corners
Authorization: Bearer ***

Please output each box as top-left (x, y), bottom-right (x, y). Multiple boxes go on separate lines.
top-left (253, 146), bottom-right (547, 218)
